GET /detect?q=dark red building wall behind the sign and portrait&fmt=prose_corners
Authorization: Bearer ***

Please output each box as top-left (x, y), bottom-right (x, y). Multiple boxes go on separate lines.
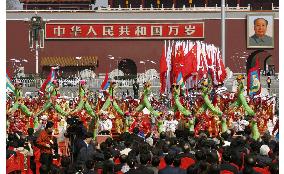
top-left (6, 19), bottom-right (279, 73)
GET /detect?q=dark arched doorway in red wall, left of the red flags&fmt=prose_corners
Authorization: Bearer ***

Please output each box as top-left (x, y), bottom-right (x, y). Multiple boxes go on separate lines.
top-left (118, 59), bottom-right (137, 79)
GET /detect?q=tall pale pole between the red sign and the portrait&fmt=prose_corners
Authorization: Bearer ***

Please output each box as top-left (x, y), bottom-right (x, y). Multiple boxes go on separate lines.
top-left (221, 0), bottom-right (226, 65)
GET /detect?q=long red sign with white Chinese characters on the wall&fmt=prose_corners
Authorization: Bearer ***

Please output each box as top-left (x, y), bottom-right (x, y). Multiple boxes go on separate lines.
top-left (45, 22), bottom-right (204, 39)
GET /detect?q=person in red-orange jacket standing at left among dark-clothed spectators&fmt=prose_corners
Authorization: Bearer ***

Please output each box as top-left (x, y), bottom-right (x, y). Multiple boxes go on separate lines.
top-left (37, 121), bottom-right (54, 169)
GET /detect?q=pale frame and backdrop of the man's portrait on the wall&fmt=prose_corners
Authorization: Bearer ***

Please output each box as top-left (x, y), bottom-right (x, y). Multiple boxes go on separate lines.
top-left (247, 14), bottom-right (274, 48)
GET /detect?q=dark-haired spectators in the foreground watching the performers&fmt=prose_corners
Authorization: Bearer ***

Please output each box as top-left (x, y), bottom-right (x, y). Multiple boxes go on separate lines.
top-left (7, 121), bottom-right (279, 174)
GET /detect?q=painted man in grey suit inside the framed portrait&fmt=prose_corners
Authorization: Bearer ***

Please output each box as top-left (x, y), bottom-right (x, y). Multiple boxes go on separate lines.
top-left (249, 18), bottom-right (273, 46)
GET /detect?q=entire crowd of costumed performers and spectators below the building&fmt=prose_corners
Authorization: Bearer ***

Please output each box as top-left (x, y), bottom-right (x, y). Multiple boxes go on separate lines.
top-left (6, 75), bottom-right (279, 174)
